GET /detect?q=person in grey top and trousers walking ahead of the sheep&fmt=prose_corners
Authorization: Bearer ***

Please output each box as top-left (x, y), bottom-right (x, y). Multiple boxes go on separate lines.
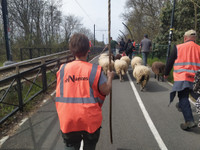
top-left (140, 34), bottom-right (151, 66)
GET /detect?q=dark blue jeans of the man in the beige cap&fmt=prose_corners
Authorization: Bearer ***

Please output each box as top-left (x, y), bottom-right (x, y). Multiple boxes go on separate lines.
top-left (178, 88), bottom-right (194, 122)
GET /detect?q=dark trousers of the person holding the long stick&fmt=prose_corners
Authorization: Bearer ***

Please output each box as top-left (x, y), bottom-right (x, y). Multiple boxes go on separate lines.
top-left (61, 128), bottom-right (100, 150)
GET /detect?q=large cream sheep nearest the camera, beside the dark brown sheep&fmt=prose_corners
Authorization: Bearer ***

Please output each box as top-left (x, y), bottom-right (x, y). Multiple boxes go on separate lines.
top-left (133, 65), bottom-right (150, 91)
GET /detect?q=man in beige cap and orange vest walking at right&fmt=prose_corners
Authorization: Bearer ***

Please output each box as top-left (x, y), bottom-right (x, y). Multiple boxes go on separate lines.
top-left (165, 30), bottom-right (200, 130)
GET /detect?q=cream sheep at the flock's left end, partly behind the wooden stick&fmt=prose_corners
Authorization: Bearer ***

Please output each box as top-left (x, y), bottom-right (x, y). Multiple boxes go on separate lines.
top-left (98, 53), bottom-right (114, 75)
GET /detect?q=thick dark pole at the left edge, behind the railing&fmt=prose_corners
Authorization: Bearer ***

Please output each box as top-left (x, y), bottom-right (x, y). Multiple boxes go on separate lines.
top-left (1, 0), bottom-right (13, 65)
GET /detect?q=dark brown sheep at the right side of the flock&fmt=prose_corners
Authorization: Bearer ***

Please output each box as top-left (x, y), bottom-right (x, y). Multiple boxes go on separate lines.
top-left (151, 61), bottom-right (165, 81)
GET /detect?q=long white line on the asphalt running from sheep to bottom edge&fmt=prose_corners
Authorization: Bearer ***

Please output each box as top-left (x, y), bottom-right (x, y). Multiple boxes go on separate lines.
top-left (127, 73), bottom-right (168, 150)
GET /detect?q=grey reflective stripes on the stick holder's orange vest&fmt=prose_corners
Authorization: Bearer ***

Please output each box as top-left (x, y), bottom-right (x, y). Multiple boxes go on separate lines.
top-left (55, 64), bottom-right (104, 104)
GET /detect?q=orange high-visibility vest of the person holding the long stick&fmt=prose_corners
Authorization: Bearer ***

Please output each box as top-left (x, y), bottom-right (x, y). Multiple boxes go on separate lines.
top-left (55, 61), bottom-right (105, 133)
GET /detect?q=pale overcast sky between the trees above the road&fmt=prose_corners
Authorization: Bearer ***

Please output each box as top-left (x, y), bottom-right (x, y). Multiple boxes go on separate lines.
top-left (62, 0), bottom-right (126, 43)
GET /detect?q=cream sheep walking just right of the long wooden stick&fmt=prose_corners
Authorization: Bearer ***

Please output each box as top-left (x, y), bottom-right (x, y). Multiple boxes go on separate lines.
top-left (114, 59), bottom-right (128, 81)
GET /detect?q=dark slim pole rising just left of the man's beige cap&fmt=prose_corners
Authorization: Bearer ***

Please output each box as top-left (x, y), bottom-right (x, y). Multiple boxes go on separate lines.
top-left (166, 0), bottom-right (176, 62)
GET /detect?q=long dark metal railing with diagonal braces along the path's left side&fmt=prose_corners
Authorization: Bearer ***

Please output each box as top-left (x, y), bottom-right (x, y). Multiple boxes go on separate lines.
top-left (0, 51), bottom-right (74, 124)
